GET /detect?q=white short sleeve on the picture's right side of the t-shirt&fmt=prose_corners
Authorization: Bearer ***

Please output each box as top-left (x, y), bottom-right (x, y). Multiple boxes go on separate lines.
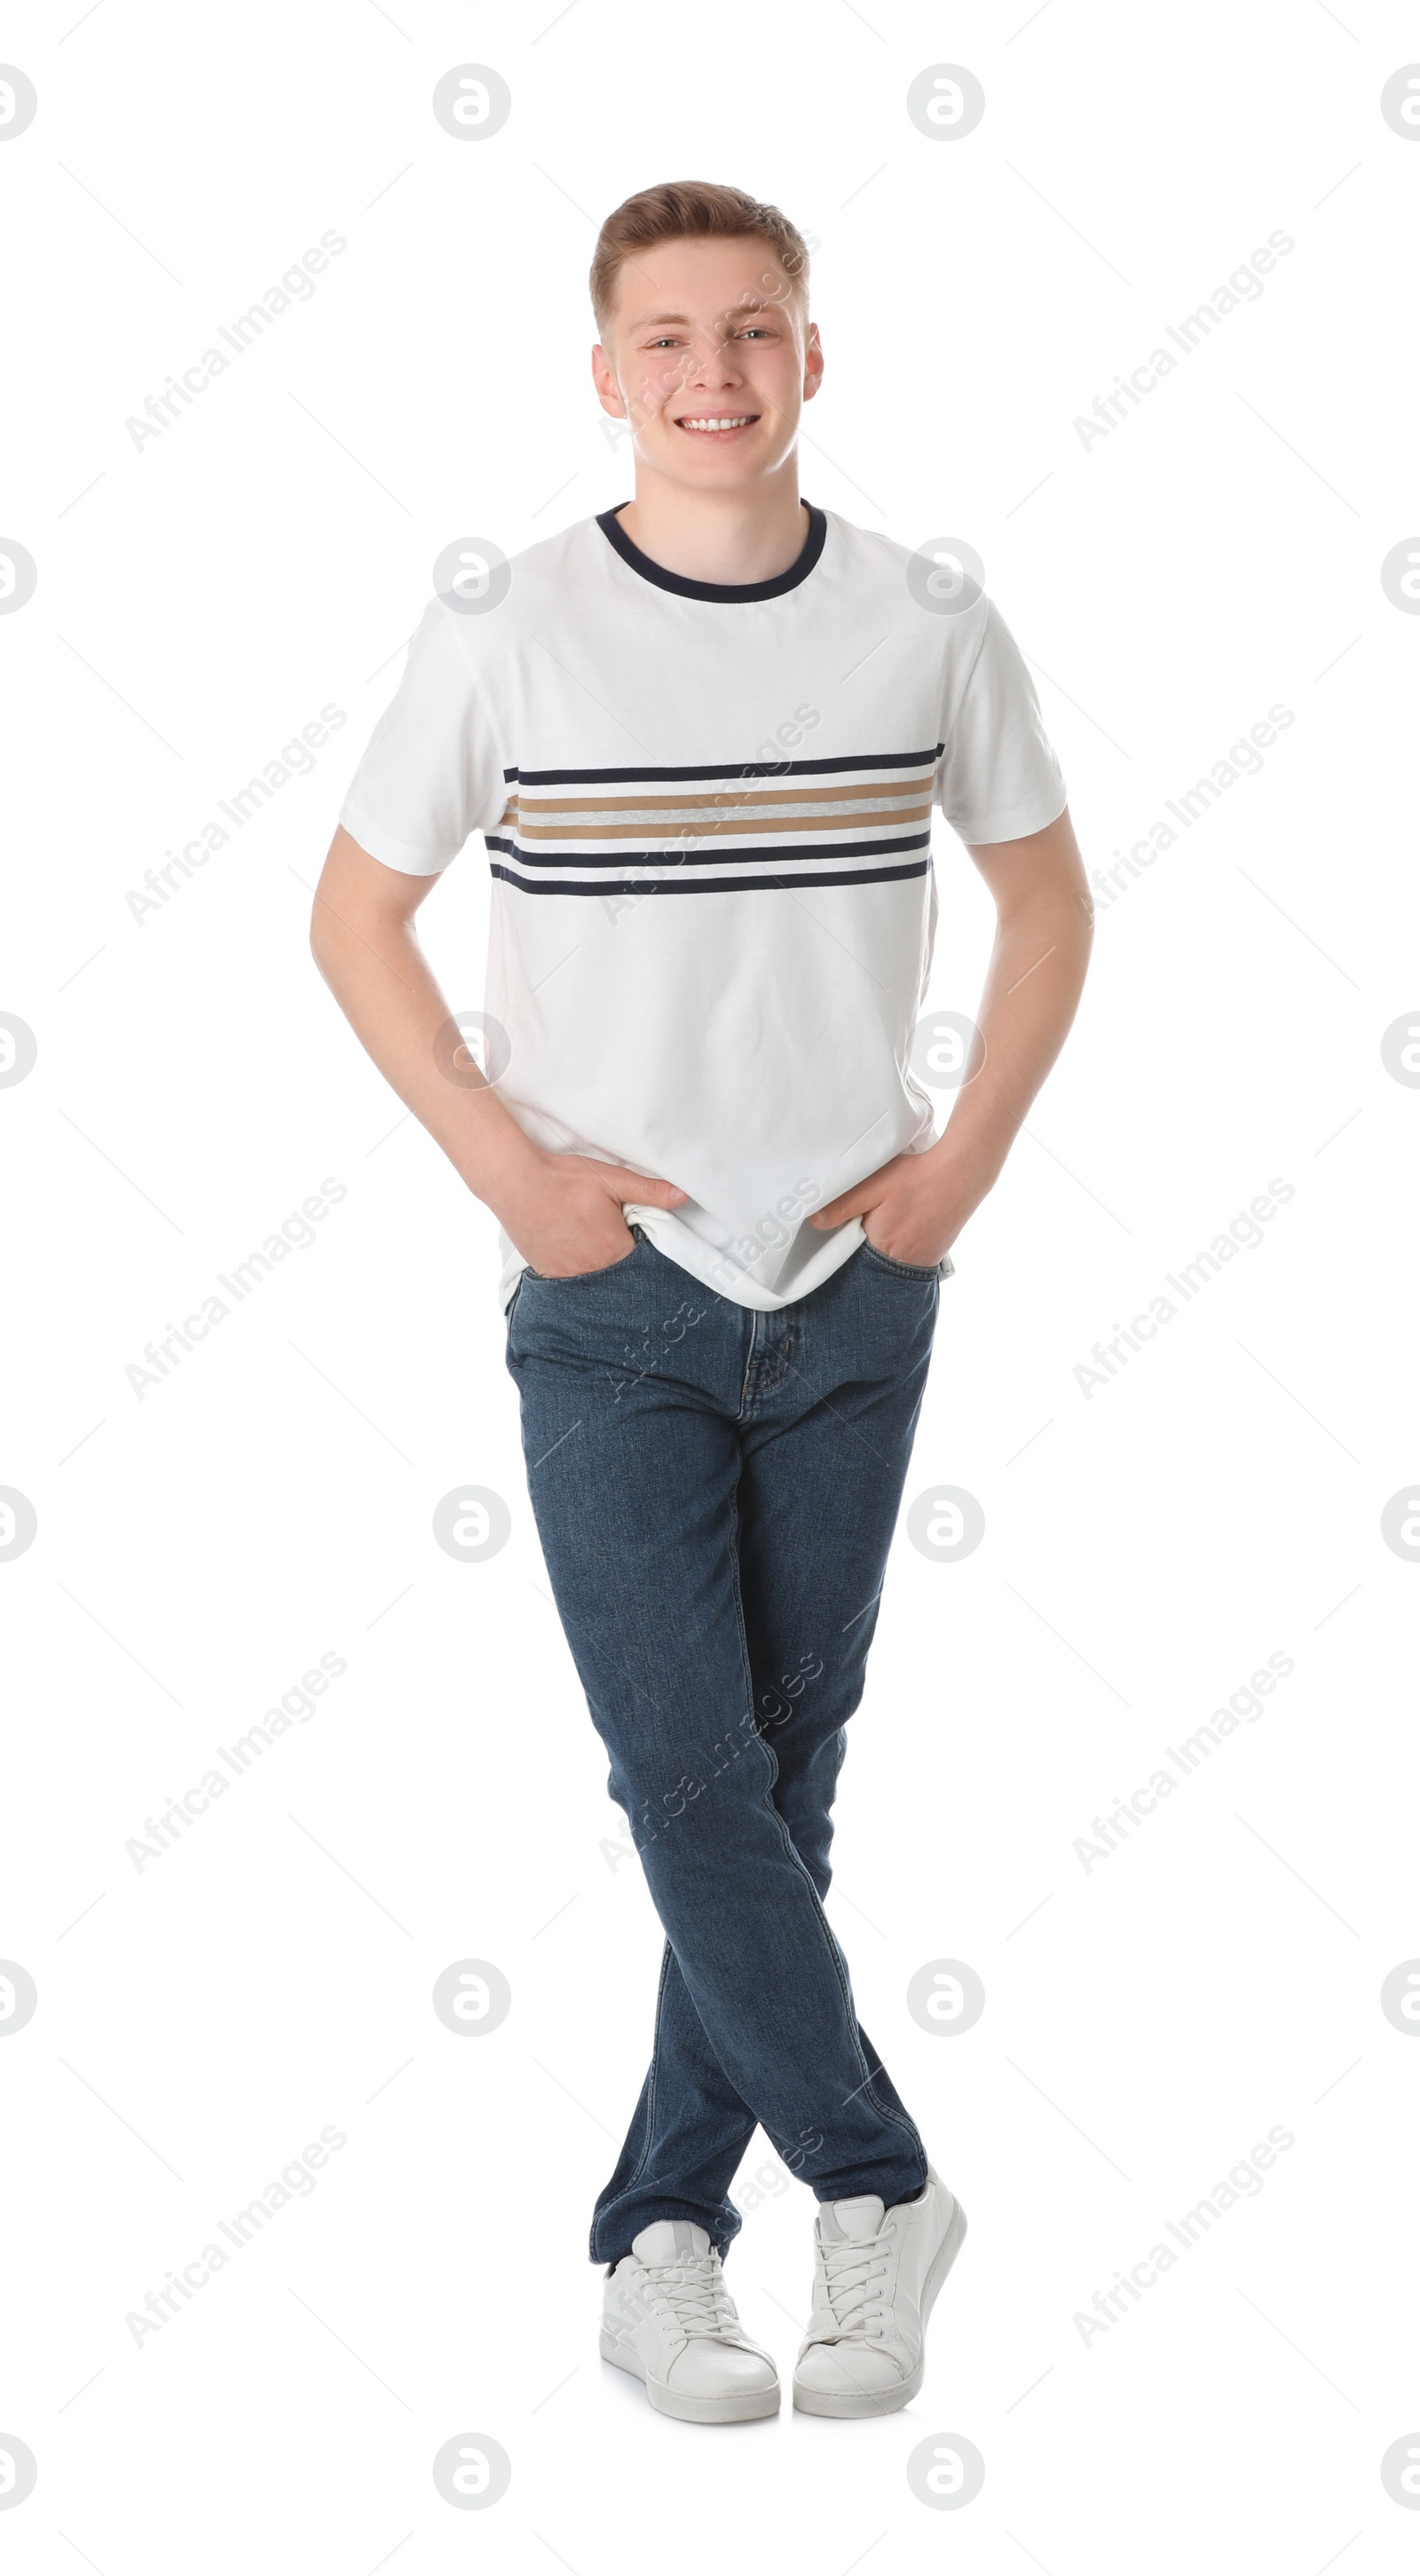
top-left (935, 600), bottom-right (1064, 842)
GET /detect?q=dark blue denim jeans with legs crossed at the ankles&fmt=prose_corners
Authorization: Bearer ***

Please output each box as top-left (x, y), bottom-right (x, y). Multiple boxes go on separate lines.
top-left (508, 1229), bottom-right (938, 2262)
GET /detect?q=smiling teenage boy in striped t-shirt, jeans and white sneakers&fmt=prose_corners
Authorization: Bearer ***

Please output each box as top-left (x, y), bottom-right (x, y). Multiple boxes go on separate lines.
top-left (312, 183), bottom-right (1090, 2424)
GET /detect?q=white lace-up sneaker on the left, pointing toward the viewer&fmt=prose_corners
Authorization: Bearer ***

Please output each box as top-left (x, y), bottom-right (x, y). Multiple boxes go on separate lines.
top-left (601, 2218), bottom-right (778, 2424)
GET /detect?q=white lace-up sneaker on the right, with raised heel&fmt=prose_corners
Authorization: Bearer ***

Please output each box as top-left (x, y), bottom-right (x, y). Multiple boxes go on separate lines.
top-left (793, 2164), bottom-right (966, 2416)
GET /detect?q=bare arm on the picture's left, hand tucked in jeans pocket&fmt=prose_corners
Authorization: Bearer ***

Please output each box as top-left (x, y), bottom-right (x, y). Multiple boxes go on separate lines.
top-left (312, 827), bottom-right (685, 1278)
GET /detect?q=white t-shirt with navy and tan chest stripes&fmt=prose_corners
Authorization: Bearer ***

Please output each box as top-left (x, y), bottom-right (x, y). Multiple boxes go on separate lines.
top-left (340, 508), bottom-right (1064, 1309)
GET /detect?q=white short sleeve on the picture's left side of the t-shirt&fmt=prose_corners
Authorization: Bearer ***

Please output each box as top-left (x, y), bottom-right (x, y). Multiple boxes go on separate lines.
top-left (340, 600), bottom-right (508, 876)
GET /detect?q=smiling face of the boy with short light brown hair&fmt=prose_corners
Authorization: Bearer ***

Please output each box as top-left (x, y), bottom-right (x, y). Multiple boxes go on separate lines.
top-left (593, 234), bottom-right (822, 492)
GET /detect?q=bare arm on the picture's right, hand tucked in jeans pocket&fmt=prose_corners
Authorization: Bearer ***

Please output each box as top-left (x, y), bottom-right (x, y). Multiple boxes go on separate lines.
top-left (809, 811), bottom-right (1095, 1267)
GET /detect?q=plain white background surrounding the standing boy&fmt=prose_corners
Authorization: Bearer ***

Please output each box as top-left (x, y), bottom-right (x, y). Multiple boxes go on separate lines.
top-left (0, 0), bottom-right (1420, 2576)
